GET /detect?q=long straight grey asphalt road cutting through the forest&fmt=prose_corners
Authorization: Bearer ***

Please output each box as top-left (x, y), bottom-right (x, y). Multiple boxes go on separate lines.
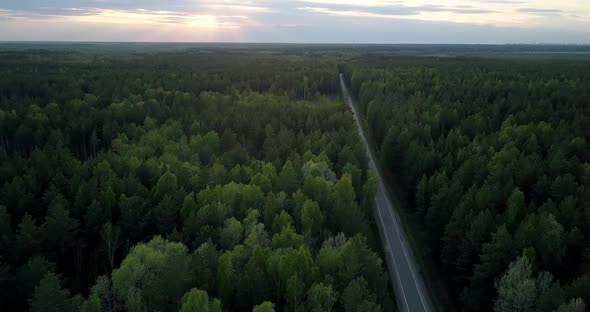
top-left (340, 74), bottom-right (432, 312)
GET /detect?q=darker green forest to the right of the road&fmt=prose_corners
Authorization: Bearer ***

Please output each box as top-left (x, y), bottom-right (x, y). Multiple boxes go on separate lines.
top-left (346, 56), bottom-right (590, 311)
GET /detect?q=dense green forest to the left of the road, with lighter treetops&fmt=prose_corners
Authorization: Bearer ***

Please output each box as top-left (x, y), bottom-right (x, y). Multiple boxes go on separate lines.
top-left (0, 46), bottom-right (398, 312)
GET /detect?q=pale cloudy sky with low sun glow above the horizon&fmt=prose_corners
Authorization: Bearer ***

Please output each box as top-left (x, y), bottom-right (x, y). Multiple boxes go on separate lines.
top-left (0, 0), bottom-right (590, 44)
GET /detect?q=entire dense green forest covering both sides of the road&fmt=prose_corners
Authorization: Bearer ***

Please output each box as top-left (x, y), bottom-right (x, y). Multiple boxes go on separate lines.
top-left (0, 44), bottom-right (590, 312)
